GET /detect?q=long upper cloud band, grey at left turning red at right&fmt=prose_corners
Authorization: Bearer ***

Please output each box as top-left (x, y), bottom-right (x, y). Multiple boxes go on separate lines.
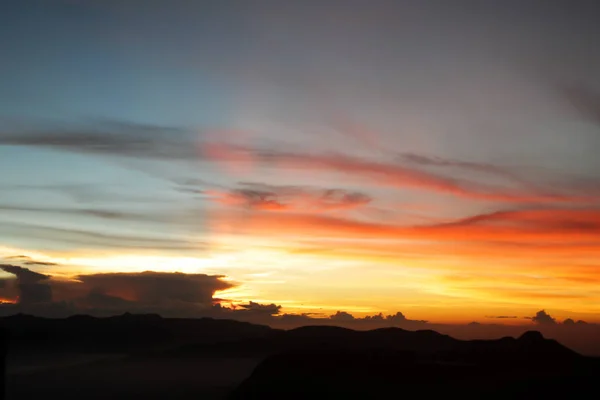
top-left (0, 121), bottom-right (597, 208)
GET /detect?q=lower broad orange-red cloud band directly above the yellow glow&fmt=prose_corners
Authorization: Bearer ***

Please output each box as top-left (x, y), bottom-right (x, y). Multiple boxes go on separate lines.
top-left (210, 209), bottom-right (600, 245)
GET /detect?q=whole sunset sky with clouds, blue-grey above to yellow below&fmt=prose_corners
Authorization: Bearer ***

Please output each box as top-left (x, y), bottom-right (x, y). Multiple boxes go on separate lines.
top-left (0, 0), bottom-right (600, 325)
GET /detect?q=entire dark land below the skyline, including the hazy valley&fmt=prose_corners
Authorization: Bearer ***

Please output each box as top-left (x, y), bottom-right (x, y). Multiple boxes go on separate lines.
top-left (1, 315), bottom-right (600, 399)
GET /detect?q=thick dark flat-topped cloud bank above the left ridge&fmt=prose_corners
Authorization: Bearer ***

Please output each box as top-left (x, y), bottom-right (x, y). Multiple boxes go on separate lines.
top-left (0, 256), bottom-right (234, 316)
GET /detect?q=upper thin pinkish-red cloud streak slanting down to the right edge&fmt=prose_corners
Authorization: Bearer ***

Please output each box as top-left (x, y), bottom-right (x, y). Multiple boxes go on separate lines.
top-left (202, 143), bottom-right (595, 203)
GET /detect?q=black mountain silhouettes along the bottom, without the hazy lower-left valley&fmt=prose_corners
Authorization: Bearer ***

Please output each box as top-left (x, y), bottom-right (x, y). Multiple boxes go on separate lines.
top-left (0, 314), bottom-right (600, 399)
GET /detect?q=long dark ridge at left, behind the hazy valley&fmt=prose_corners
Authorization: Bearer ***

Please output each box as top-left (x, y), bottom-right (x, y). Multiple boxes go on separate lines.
top-left (0, 313), bottom-right (273, 352)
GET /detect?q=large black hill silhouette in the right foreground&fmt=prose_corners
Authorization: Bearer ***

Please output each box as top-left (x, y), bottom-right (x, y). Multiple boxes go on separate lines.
top-left (230, 327), bottom-right (600, 399)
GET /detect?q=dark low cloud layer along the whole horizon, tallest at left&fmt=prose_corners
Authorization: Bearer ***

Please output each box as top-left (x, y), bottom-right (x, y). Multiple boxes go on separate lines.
top-left (0, 264), bottom-right (600, 355)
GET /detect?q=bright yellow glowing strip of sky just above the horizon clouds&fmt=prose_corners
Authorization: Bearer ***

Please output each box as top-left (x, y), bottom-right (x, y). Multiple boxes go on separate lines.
top-left (0, 241), bottom-right (600, 324)
